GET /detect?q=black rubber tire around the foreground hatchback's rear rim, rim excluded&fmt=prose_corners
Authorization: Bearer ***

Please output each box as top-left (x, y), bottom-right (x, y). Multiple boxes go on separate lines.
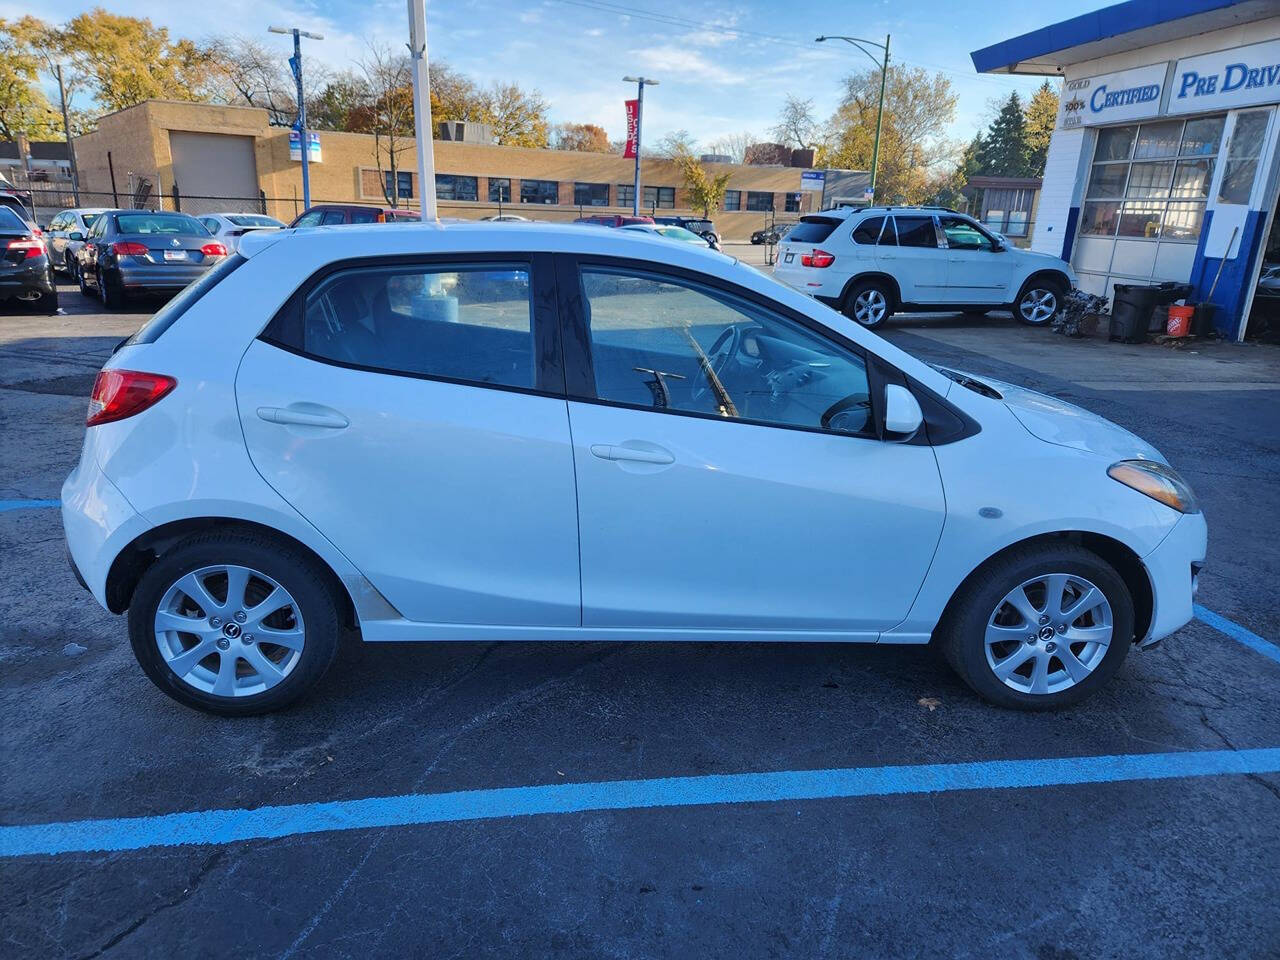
top-left (129, 532), bottom-right (342, 717)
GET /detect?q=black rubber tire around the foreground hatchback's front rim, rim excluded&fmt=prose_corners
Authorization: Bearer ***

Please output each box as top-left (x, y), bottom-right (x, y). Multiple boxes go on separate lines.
top-left (937, 543), bottom-right (1134, 710)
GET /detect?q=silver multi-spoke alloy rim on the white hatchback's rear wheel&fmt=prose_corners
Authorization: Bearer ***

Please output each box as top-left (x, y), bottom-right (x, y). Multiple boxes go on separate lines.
top-left (155, 564), bottom-right (306, 698)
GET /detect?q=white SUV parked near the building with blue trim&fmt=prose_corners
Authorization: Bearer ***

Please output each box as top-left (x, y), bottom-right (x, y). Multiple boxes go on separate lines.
top-left (773, 206), bottom-right (1075, 326)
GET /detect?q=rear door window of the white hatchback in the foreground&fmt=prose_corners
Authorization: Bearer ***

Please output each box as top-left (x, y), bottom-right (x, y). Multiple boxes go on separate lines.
top-left (277, 264), bottom-right (536, 388)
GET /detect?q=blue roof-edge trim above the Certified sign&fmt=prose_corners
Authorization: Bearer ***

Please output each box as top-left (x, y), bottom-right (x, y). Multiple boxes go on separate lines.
top-left (969, 0), bottom-right (1248, 73)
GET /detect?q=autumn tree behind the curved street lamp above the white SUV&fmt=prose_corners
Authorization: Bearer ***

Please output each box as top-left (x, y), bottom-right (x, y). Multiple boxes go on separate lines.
top-left (818, 64), bottom-right (956, 204)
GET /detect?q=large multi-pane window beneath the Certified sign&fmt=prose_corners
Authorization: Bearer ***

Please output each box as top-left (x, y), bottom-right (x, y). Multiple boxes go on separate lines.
top-left (1085, 114), bottom-right (1223, 243)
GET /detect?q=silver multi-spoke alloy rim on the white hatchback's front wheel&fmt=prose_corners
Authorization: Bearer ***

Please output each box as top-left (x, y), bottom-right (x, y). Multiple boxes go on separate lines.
top-left (984, 573), bottom-right (1114, 695)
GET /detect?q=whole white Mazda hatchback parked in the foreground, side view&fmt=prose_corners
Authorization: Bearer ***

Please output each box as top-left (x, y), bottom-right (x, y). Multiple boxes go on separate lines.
top-left (63, 224), bottom-right (1206, 714)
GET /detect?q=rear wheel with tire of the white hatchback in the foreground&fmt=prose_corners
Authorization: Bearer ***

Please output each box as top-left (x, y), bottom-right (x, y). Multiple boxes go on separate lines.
top-left (129, 532), bottom-right (340, 716)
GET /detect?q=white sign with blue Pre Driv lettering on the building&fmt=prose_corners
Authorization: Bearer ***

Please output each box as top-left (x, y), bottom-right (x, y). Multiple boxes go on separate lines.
top-left (1169, 40), bottom-right (1280, 114)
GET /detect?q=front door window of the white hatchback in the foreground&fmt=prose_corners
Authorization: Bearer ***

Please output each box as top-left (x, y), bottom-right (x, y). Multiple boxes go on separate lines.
top-left (582, 268), bottom-right (872, 434)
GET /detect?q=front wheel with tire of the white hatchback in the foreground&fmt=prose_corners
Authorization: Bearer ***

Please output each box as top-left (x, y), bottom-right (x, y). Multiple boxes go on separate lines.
top-left (938, 544), bottom-right (1134, 710)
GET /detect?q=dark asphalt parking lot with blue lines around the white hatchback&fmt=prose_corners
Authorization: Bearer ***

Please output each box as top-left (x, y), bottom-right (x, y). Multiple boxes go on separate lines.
top-left (0, 287), bottom-right (1280, 960)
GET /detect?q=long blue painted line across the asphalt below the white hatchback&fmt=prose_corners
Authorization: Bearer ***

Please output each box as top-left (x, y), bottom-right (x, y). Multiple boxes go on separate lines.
top-left (0, 748), bottom-right (1280, 856)
